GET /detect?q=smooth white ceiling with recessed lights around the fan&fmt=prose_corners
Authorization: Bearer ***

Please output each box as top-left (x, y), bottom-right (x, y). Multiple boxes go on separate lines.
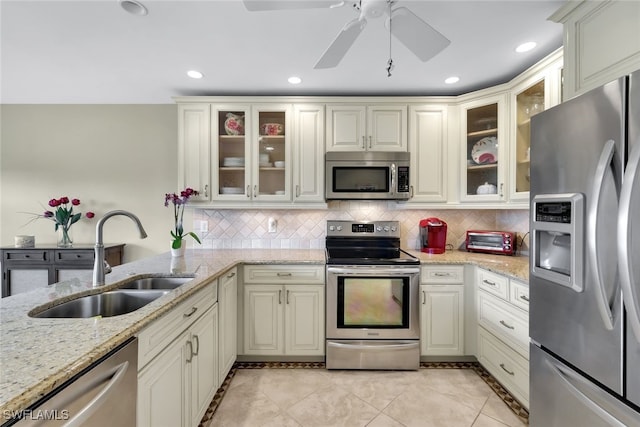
top-left (0, 0), bottom-right (564, 104)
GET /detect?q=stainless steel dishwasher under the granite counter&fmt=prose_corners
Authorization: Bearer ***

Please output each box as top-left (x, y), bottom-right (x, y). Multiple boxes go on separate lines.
top-left (2, 337), bottom-right (138, 427)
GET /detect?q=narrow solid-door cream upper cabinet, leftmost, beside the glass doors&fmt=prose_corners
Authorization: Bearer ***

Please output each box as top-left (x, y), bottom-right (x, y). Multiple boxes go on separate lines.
top-left (178, 103), bottom-right (211, 202)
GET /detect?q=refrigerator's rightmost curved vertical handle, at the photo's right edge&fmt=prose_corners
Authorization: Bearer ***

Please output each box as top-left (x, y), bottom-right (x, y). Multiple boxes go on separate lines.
top-left (618, 143), bottom-right (640, 341)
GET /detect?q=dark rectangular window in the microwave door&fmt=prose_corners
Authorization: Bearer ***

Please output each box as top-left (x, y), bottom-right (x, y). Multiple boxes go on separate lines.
top-left (332, 166), bottom-right (389, 193)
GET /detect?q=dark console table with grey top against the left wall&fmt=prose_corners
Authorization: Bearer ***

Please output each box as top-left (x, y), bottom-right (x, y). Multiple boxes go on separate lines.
top-left (0, 243), bottom-right (124, 298)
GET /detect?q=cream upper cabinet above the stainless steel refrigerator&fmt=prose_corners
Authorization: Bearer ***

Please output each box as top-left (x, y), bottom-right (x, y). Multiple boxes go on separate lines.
top-left (549, 0), bottom-right (640, 100)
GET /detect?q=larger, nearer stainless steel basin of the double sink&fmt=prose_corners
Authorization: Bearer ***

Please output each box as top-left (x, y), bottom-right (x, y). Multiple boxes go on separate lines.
top-left (31, 290), bottom-right (169, 318)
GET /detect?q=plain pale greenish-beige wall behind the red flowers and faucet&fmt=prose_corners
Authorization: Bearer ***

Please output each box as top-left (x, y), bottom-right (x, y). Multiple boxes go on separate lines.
top-left (0, 104), bottom-right (180, 261)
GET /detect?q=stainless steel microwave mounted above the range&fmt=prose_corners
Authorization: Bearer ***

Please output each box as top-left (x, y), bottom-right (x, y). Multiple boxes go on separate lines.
top-left (325, 151), bottom-right (411, 200)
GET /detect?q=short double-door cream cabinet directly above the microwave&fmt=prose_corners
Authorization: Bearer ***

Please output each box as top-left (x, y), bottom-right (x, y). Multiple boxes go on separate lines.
top-left (326, 104), bottom-right (408, 151)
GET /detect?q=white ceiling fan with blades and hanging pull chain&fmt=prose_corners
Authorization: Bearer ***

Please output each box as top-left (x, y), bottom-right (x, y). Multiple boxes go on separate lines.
top-left (243, 0), bottom-right (451, 75)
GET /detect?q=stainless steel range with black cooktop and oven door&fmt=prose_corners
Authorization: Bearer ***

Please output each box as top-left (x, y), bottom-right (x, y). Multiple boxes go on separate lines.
top-left (326, 221), bottom-right (420, 370)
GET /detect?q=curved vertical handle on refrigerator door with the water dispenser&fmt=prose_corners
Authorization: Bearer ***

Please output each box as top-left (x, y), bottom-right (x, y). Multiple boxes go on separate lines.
top-left (585, 139), bottom-right (616, 330)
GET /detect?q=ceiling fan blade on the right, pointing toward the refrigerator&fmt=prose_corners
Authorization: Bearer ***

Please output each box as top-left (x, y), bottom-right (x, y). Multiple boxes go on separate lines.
top-left (391, 7), bottom-right (451, 62)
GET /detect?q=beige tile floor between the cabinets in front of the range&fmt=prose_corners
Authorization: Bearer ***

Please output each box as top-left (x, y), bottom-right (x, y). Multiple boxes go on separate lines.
top-left (207, 368), bottom-right (526, 427)
